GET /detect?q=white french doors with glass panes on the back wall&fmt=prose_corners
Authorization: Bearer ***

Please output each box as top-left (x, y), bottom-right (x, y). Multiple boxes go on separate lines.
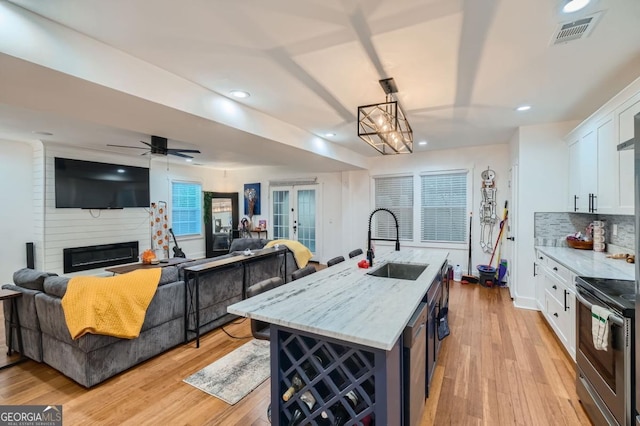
top-left (271, 185), bottom-right (319, 260)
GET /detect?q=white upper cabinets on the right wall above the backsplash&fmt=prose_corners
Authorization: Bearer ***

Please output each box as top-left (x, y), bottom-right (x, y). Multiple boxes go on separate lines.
top-left (565, 75), bottom-right (640, 214)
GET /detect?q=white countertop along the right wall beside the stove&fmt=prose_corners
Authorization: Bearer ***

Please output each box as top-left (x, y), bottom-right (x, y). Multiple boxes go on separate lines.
top-left (536, 246), bottom-right (636, 280)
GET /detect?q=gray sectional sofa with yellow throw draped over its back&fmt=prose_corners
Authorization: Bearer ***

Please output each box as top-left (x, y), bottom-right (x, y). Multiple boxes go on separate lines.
top-left (3, 239), bottom-right (298, 387)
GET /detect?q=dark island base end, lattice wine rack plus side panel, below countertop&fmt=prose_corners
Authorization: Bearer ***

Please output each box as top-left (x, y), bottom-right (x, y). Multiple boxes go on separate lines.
top-left (270, 324), bottom-right (402, 426)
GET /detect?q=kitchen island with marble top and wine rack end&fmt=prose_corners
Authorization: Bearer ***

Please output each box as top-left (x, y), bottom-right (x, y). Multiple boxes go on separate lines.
top-left (228, 248), bottom-right (448, 425)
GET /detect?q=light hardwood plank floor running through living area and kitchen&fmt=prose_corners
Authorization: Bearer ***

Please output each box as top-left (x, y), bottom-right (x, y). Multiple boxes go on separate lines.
top-left (0, 282), bottom-right (590, 426)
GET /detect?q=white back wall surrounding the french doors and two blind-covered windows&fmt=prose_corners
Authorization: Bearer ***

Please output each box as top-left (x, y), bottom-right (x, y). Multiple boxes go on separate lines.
top-left (222, 144), bottom-right (510, 268)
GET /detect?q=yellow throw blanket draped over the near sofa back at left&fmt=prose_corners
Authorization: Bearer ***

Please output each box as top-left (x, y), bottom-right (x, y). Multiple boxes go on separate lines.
top-left (62, 268), bottom-right (162, 340)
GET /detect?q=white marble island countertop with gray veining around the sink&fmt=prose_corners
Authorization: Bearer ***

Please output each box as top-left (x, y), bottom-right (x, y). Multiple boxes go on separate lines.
top-left (227, 248), bottom-right (448, 350)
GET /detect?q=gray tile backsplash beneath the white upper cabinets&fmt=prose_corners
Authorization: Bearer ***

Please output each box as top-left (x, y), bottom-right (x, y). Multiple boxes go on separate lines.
top-left (534, 213), bottom-right (635, 250)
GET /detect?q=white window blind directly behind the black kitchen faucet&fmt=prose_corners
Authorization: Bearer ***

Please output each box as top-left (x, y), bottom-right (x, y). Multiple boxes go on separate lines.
top-left (373, 176), bottom-right (413, 240)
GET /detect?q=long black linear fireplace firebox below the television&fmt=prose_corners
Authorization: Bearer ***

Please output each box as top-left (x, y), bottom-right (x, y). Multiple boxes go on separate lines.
top-left (63, 241), bottom-right (138, 273)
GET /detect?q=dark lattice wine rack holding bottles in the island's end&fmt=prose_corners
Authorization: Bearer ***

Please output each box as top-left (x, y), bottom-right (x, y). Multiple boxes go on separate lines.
top-left (272, 329), bottom-right (384, 426)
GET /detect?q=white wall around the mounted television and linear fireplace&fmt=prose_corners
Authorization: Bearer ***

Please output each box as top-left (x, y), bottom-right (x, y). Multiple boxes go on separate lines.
top-left (0, 141), bottom-right (225, 276)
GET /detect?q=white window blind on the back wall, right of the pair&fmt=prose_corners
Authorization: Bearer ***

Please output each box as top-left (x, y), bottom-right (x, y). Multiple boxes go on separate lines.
top-left (420, 172), bottom-right (467, 243)
